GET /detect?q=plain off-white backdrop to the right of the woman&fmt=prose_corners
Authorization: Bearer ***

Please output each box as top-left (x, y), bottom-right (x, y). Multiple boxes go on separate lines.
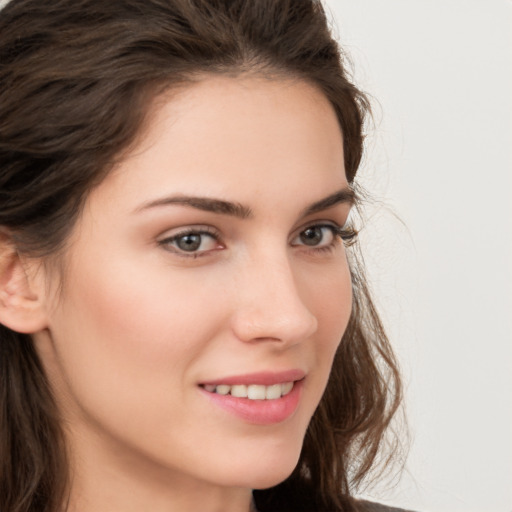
top-left (326, 0), bottom-right (512, 512)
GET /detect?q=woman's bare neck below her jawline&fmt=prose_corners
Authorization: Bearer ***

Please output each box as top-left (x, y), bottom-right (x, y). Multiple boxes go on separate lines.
top-left (65, 424), bottom-right (256, 512)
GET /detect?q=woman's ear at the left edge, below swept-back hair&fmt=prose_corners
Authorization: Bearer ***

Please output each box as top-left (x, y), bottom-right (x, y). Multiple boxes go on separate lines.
top-left (0, 231), bottom-right (47, 334)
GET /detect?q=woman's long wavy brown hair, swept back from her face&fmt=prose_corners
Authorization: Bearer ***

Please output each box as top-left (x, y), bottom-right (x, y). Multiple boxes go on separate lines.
top-left (0, 0), bottom-right (401, 512)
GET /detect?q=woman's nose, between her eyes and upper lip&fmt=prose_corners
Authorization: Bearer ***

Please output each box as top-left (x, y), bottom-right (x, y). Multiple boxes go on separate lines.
top-left (232, 257), bottom-right (318, 346)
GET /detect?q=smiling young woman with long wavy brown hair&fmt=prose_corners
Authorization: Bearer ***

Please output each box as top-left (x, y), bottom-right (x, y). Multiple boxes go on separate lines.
top-left (0, 0), bottom-right (408, 512)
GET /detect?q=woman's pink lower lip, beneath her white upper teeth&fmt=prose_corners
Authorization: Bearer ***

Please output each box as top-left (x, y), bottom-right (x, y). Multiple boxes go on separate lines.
top-left (201, 381), bottom-right (303, 425)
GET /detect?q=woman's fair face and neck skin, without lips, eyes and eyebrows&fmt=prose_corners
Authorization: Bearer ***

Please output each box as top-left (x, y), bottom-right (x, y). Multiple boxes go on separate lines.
top-left (34, 77), bottom-right (352, 512)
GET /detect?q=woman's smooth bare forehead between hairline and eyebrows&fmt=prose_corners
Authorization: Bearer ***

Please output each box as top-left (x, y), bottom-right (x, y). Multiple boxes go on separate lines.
top-left (88, 76), bottom-right (346, 214)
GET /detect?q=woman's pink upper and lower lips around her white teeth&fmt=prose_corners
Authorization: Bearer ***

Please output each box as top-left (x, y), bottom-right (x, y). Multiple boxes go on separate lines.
top-left (199, 370), bottom-right (305, 425)
